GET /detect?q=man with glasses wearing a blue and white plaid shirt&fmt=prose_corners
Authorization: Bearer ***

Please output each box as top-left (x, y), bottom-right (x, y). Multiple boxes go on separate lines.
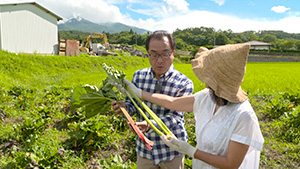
top-left (112, 31), bottom-right (194, 169)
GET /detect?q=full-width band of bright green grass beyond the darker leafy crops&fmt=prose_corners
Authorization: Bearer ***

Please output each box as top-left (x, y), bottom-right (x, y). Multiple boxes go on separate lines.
top-left (0, 51), bottom-right (300, 95)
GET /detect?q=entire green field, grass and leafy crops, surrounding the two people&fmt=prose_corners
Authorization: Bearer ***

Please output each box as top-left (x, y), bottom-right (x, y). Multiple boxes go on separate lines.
top-left (0, 51), bottom-right (300, 168)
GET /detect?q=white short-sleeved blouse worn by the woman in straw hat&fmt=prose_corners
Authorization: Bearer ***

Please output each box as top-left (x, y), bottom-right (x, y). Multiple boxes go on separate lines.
top-left (193, 89), bottom-right (264, 169)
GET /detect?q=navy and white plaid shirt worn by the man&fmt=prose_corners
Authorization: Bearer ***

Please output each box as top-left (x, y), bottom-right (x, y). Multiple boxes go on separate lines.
top-left (125, 65), bottom-right (194, 165)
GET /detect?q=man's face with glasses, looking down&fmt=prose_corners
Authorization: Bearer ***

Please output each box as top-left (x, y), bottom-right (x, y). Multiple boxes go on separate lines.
top-left (148, 37), bottom-right (175, 79)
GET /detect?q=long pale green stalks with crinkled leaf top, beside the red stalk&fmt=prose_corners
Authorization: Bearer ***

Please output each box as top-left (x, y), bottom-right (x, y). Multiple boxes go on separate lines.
top-left (103, 63), bottom-right (174, 136)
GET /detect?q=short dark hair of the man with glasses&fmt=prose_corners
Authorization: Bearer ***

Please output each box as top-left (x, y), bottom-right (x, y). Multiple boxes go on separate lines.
top-left (146, 30), bottom-right (176, 52)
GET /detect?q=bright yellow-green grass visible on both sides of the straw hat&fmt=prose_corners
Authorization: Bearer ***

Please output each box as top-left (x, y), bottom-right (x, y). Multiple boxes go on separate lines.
top-left (175, 62), bottom-right (300, 95)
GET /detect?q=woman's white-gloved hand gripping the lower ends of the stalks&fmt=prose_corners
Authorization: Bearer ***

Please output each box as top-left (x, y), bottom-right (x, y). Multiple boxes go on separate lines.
top-left (160, 135), bottom-right (197, 158)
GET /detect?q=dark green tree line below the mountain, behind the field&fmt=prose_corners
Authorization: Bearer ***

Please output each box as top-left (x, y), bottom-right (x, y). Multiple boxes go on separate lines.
top-left (58, 27), bottom-right (300, 52)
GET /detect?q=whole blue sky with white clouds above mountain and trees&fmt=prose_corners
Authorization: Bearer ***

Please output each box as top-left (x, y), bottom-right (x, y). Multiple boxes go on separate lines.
top-left (4, 0), bottom-right (300, 33)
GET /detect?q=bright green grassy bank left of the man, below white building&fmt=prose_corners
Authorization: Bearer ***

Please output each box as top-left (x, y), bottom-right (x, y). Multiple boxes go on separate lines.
top-left (0, 51), bottom-right (149, 88)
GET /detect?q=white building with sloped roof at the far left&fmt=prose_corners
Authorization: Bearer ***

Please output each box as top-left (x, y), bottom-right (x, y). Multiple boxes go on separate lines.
top-left (0, 2), bottom-right (62, 54)
